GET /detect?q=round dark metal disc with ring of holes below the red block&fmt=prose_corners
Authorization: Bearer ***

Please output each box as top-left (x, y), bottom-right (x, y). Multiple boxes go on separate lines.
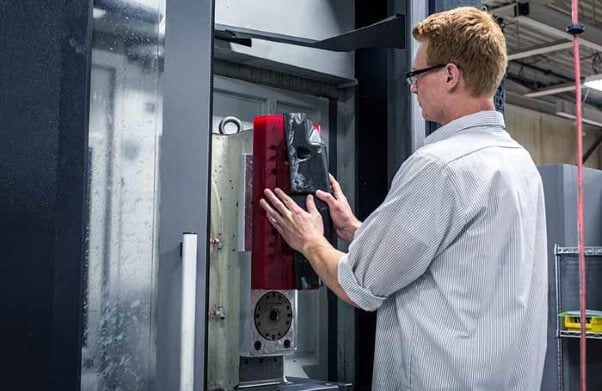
top-left (254, 291), bottom-right (293, 343)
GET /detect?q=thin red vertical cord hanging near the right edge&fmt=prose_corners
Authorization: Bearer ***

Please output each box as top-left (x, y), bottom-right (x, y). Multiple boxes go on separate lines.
top-left (572, 0), bottom-right (587, 391)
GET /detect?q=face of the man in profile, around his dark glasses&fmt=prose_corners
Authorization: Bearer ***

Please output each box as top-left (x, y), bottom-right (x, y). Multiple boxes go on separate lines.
top-left (410, 42), bottom-right (444, 122)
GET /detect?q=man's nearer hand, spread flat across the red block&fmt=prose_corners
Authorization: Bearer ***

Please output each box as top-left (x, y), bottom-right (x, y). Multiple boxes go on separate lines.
top-left (259, 189), bottom-right (326, 254)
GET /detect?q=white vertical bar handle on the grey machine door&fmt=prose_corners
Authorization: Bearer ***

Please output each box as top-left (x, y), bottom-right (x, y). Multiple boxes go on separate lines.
top-left (180, 233), bottom-right (198, 391)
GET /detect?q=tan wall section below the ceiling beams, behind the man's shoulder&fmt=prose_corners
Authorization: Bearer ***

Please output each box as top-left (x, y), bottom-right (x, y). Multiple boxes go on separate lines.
top-left (505, 105), bottom-right (602, 168)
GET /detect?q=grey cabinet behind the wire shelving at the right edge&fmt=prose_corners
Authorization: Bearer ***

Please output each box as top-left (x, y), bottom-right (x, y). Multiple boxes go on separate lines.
top-left (539, 164), bottom-right (602, 391)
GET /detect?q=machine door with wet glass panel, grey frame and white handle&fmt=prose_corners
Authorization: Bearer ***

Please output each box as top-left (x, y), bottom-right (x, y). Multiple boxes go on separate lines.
top-left (79, 0), bottom-right (213, 391)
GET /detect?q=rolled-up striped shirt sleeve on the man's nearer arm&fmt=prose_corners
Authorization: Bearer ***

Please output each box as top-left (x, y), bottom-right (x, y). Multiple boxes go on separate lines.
top-left (337, 154), bottom-right (464, 311)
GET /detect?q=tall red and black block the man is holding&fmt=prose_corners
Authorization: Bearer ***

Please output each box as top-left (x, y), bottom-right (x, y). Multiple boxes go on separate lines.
top-left (251, 113), bottom-right (332, 290)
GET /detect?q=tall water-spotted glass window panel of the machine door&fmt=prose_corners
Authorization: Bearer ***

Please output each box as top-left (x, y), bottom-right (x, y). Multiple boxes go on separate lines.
top-left (81, 0), bottom-right (165, 391)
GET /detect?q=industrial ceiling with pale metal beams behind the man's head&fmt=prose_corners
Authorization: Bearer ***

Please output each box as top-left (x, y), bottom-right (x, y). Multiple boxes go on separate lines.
top-left (483, 0), bottom-right (602, 128)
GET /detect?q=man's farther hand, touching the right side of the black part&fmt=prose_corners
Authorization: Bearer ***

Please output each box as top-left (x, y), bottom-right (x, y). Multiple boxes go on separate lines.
top-left (316, 175), bottom-right (362, 242)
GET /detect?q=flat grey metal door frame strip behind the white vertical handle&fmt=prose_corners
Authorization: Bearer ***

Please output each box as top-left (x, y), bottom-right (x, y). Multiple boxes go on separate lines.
top-left (155, 0), bottom-right (214, 391)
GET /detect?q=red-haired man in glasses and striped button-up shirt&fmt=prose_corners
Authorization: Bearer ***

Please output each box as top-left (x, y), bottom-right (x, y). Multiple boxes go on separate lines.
top-left (261, 7), bottom-right (547, 391)
